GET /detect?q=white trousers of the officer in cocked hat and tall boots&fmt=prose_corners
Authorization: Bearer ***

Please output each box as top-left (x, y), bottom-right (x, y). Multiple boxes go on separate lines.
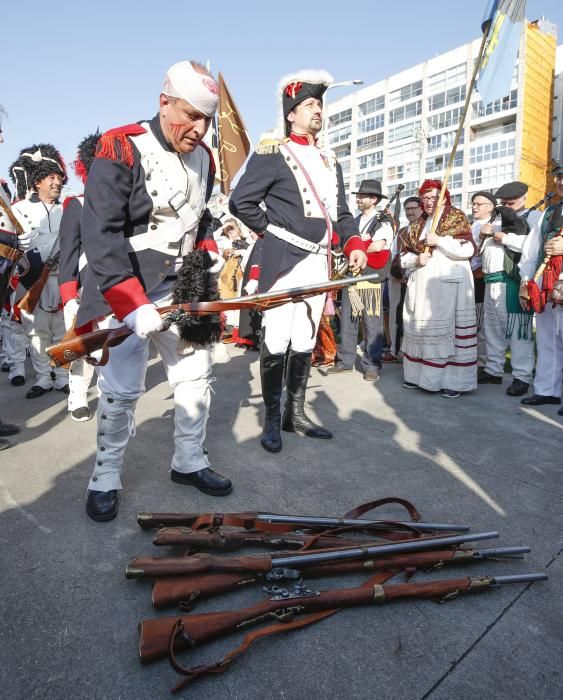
top-left (262, 253), bottom-right (328, 355)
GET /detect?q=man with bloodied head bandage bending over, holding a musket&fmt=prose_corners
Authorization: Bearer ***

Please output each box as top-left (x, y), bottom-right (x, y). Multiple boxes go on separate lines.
top-left (77, 61), bottom-right (232, 521)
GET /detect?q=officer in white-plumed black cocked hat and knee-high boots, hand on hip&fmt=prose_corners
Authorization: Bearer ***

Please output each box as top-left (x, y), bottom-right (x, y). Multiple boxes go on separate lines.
top-left (229, 71), bottom-right (367, 452)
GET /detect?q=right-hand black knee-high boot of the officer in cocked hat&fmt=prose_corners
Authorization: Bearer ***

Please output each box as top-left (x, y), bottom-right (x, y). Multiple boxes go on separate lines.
top-left (282, 350), bottom-right (332, 440)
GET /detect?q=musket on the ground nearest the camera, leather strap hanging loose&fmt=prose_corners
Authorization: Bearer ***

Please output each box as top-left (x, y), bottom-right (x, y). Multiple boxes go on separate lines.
top-left (139, 573), bottom-right (547, 690)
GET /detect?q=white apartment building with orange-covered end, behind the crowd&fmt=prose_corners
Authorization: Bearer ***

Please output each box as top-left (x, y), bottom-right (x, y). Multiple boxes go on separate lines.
top-left (327, 20), bottom-right (563, 210)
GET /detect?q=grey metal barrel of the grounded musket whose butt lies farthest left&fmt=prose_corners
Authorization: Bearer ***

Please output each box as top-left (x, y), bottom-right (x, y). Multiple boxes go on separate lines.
top-left (272, 532), bottom-right (498, 567)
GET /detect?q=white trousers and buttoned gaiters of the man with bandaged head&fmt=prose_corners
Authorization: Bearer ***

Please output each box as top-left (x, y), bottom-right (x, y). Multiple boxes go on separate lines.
top-left (88, 306), bottom-right (215, 491)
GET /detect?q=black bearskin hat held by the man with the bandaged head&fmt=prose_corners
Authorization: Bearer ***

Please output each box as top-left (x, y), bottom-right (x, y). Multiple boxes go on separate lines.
top-left (166, 250), bottom-right (223, 348)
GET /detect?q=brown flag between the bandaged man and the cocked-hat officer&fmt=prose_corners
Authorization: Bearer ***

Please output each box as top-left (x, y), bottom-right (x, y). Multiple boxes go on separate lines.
top-left (217, 73), bottom-right (250, 194)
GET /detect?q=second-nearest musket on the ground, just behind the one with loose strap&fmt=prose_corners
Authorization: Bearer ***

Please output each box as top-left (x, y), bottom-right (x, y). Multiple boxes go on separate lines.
top-left (152, 547), bottom-right (530, 610)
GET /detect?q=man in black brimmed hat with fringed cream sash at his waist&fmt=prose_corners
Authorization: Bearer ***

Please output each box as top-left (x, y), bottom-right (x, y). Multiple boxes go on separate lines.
top-left (327, 180), bottom-right (393, 382)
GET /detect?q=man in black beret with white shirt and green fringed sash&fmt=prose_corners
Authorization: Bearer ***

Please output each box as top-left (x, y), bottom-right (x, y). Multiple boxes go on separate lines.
top-left (478, 182), bottom-right (539, 396)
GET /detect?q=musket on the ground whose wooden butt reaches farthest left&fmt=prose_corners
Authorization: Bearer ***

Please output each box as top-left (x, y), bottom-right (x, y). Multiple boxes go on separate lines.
top-left (125, 532), bottom-right (498, 578)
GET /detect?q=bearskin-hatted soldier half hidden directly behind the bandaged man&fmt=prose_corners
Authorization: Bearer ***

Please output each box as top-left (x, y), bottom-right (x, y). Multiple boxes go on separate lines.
top-left (59, 131), bottom-right (100, 422)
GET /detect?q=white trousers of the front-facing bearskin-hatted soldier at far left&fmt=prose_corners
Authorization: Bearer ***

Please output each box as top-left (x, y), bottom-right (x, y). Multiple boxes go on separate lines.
top-left (21, 275), bottom-right (68, 389)
